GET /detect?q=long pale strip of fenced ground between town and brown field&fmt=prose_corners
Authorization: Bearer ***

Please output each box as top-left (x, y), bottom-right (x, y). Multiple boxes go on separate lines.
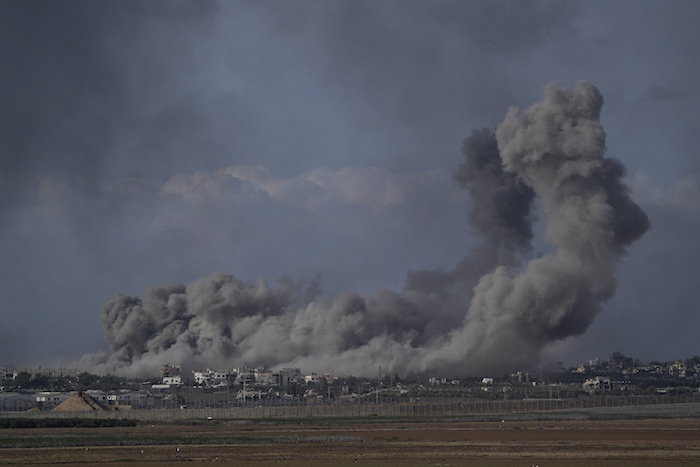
top-left (0, 393), bottom-right (700, 421)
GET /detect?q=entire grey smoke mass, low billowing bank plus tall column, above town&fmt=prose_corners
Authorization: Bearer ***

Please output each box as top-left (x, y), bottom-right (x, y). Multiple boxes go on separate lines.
top-left (85, 82), bottom-right (649, 375)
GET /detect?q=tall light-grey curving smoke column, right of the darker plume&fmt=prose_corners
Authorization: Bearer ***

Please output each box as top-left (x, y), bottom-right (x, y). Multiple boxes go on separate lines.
top-left (422, 82), bottom-right (649, 373)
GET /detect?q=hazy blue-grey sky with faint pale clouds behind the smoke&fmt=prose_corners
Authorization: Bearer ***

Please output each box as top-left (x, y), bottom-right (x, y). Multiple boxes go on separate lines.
top-left (0, 0), bottom-right (700, 371)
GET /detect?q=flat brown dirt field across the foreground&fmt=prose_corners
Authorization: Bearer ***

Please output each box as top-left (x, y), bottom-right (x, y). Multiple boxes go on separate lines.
top-left (0, 419), bottom-right (700, 467)
